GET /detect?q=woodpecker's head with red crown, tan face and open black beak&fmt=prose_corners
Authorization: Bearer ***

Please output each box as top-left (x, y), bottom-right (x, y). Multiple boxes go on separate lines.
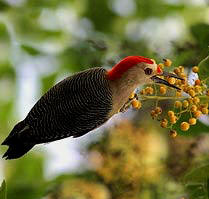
top-left (107, 56), bottom-right (182, 89)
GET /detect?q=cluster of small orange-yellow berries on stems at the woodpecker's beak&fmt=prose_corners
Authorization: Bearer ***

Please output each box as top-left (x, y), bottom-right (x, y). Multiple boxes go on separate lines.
top-left (130, 59), bottom-right (209, 137)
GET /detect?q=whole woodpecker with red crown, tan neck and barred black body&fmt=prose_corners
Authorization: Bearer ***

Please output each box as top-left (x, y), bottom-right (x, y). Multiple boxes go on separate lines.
top-left (2, 56), bottom-right (181, 159)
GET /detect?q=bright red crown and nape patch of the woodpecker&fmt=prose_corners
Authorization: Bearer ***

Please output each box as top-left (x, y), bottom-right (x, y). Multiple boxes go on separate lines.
top-left (107, 56), bottom-right (154, 80)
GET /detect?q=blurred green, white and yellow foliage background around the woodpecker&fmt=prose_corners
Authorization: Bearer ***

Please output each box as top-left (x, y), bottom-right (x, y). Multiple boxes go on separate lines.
top-left (0, 0), bottom-right (209, 199)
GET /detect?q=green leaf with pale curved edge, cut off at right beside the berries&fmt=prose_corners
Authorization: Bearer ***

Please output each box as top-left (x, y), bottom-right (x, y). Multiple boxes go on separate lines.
top-left (198, 56), bottom-right (209, 86)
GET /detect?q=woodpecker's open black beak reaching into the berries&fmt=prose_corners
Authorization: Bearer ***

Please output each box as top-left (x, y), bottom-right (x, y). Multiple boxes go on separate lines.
top-left (151, 71), bottom-right (183, 90)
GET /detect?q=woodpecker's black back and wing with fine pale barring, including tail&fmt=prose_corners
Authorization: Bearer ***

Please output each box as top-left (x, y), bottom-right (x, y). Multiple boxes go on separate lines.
top-left (2, 68), bottom-right (112, 159)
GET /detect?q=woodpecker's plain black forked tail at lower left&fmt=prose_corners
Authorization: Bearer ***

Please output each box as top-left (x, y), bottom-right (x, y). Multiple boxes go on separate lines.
top-left (2, 121), bottom-right (35, 159)
